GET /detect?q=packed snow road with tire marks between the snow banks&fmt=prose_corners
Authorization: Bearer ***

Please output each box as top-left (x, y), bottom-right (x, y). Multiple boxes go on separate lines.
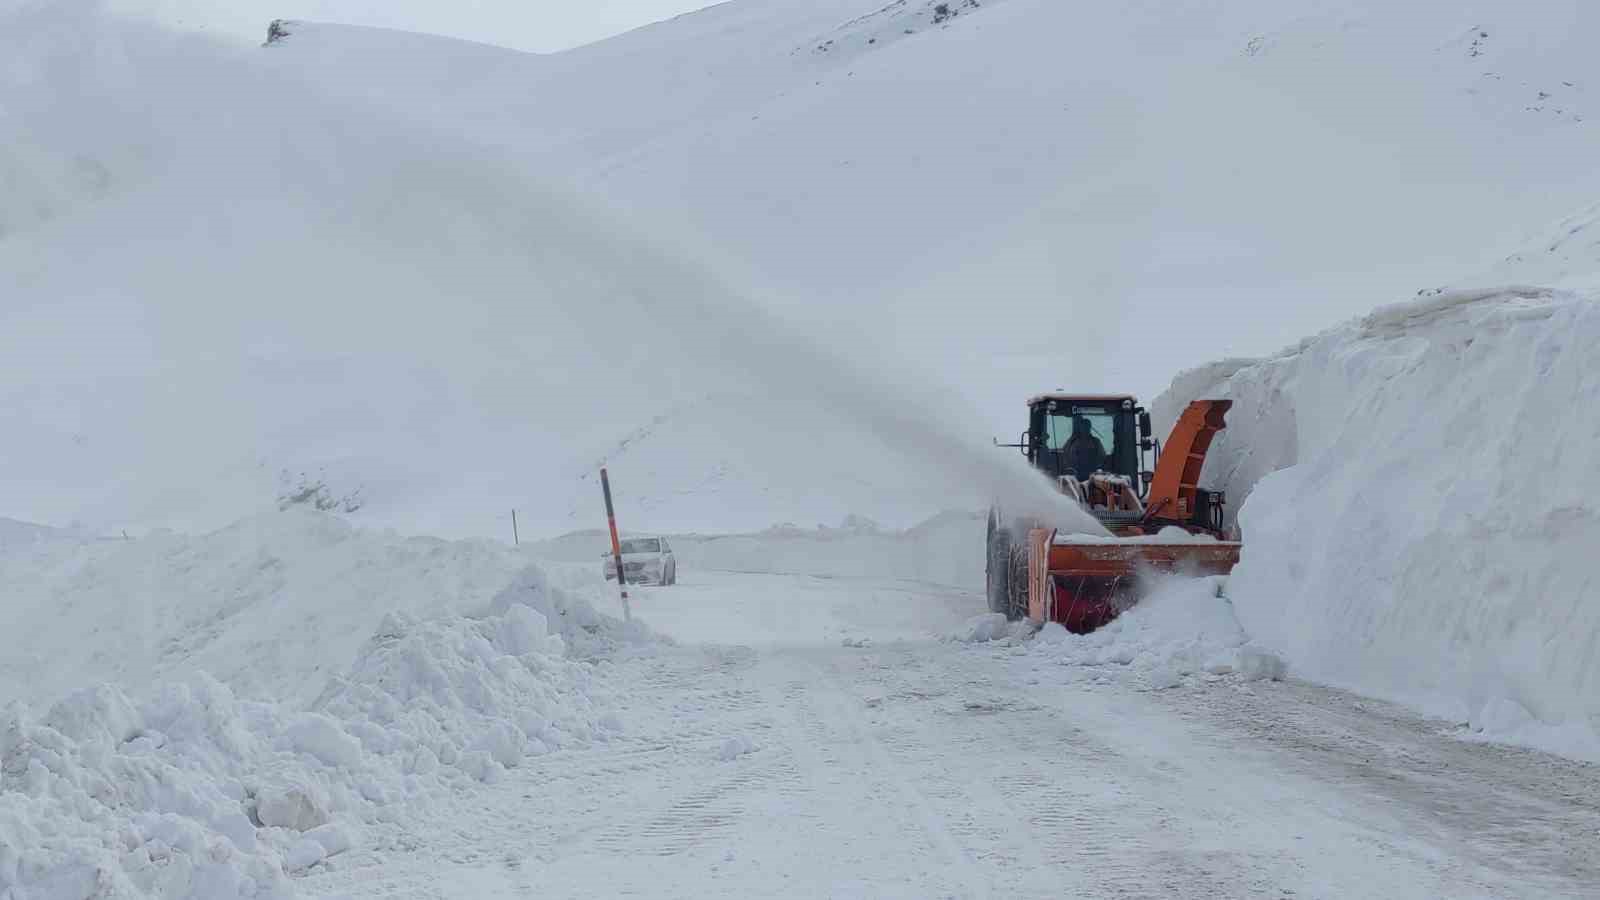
top-left (301, 570), bottom-right (1600, 898)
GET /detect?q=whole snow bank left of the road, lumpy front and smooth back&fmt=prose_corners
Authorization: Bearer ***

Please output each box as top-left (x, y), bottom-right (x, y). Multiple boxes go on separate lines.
top-left (0, 512), bottom-right (651, 900)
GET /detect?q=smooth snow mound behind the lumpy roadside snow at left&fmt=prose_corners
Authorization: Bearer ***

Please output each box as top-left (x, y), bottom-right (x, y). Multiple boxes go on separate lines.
top-left (0, 509), bottom-right (540, 705)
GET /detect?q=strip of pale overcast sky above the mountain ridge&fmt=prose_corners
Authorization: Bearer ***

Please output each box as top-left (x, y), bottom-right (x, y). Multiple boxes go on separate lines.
top-left (109, 0), bottom-right (710, 53)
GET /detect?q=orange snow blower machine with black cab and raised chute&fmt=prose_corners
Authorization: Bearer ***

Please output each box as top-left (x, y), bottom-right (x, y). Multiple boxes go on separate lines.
top-left (986, 394), bottom-right (1240, 634)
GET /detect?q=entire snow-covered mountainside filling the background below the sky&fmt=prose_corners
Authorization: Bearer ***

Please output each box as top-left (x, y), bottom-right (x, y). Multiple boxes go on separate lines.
top-left (0, 0), bottom-right (1600, 536)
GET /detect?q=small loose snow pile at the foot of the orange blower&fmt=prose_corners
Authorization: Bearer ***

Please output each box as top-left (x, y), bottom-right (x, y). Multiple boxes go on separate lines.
top-left (1035, 577), bottom-right (1285, 689)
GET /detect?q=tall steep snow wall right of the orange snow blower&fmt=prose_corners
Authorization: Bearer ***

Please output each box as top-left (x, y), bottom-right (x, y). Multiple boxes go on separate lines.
top-left (1154, 288), bottom-right (1600, 757)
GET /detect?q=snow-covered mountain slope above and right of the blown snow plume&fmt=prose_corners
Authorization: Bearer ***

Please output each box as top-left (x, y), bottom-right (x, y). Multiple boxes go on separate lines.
top-left (259, 0), bottom-right (1600, 398)
